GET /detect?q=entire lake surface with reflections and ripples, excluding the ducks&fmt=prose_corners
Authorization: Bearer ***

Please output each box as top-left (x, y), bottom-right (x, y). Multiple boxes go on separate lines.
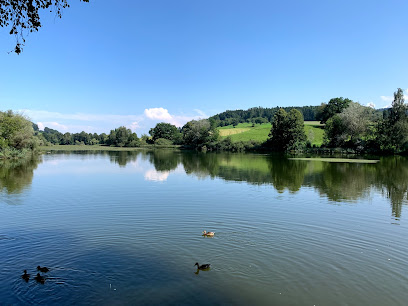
top-left (0, 150), bottom-right (408, 305)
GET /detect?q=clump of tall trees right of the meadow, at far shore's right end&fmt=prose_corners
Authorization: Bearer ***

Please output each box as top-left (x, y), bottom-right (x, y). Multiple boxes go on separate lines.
top-left (320, 88), bottom-right (408, 153)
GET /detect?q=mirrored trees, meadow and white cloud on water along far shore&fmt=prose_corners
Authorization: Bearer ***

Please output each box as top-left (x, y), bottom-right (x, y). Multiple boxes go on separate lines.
top-left (0, 150), bottom-right (408, 218)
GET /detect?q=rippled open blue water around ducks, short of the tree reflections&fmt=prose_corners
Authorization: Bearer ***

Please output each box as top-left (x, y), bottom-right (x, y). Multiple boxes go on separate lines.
top-left (0, 155), bottom-right (408, 305)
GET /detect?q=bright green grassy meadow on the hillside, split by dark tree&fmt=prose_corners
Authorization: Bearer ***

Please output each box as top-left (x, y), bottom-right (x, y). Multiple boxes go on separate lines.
top-left (218, 121), bottom-right (324, 146)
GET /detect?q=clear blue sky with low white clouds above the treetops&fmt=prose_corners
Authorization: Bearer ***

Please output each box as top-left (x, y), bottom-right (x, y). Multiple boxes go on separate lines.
top-left (0, 0), bottom-right (408, 135)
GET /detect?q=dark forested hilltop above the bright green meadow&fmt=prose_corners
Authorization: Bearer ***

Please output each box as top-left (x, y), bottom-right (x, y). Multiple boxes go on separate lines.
top-left (209, 106), bottom-right (319, 126)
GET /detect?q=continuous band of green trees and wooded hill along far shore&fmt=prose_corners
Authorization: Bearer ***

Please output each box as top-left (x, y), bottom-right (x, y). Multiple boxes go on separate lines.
top-left (0, 88), bottom-right (408, 158)
